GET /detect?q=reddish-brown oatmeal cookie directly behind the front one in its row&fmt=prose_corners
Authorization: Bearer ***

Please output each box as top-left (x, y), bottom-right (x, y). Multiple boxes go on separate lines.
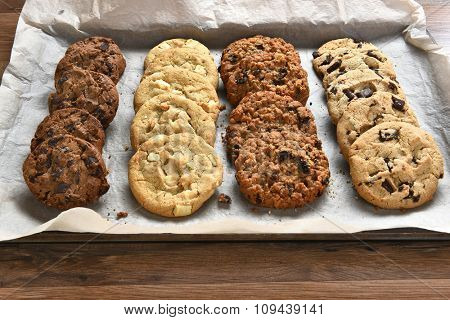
top-left (226, 91), bottom-right (320, 161)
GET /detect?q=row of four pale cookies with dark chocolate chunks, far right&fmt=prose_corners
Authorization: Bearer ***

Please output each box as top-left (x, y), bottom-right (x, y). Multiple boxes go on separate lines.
top-left (313, 38), bottom-right (444, 209)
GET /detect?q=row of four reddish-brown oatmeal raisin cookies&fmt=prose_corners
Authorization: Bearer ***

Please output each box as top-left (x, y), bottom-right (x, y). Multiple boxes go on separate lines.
top-left (220, 36), bottom-right (330, 208)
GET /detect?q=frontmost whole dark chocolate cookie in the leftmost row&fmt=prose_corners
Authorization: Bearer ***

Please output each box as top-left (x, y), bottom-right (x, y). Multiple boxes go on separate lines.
top-left (23, 135), bottom-right (109, 210)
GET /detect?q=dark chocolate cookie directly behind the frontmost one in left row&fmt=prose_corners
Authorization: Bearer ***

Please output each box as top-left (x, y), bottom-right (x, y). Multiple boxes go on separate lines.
top-left (31, 108), bottom-right (105, 152)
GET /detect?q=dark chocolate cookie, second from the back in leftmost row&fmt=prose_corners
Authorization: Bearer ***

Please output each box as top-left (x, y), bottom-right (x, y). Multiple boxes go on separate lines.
top-left (48, 67), bottom-right (119, 128)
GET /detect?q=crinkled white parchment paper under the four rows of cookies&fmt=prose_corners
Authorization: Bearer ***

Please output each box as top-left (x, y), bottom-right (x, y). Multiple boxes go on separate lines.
top-left (0, 0), bottom-right (450, 240)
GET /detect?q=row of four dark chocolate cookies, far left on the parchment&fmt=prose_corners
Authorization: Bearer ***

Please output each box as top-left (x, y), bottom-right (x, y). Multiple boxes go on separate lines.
top-left (23, 37), bottom-right (126, 210)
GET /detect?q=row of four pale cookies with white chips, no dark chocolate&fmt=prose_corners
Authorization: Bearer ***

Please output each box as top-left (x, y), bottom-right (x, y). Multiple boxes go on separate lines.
top-left (128, 39), bottom-right (223, 217)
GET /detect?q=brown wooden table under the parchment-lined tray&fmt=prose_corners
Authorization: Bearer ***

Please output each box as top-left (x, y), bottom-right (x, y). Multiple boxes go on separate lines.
top-left (0, 0), bottom-right (450, 299)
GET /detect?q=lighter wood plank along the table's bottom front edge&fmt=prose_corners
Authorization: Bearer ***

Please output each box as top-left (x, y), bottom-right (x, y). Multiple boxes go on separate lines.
top-left (0, 279), bottom-right (450, 300)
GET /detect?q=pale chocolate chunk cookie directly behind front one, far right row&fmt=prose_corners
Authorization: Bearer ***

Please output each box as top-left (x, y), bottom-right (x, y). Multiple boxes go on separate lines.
top-left (336, 92), bottom-right (419, 159)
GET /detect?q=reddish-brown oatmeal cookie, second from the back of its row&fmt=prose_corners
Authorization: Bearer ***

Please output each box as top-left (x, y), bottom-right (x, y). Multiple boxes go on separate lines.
top-left (225, 52), bottom-right (309, 106)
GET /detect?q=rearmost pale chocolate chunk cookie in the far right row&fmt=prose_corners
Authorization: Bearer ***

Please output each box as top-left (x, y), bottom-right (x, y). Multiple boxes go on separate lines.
top-left (313, 38), bottom-right (378, 61)
